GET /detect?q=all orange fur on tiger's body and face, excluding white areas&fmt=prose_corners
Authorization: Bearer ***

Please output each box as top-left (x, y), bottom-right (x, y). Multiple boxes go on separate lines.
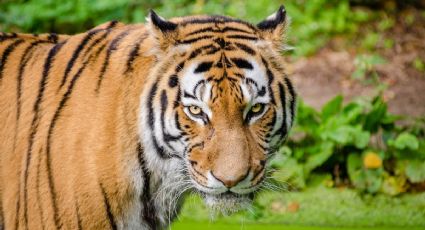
top-left (0, 6), bottom-right (295, 229)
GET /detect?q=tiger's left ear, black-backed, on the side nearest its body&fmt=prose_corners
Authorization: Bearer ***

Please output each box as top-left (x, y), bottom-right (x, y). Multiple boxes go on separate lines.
top-left (147, 10), bottom-right (177, 51)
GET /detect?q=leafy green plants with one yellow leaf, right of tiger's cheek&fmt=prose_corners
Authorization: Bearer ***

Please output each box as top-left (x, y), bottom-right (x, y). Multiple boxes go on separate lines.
top-left (273, 96), bottom-right (425, 195)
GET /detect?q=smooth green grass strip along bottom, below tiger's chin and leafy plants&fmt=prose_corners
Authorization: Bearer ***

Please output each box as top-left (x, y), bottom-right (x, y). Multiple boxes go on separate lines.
top-left (172, 186), bottom-right (425, 230)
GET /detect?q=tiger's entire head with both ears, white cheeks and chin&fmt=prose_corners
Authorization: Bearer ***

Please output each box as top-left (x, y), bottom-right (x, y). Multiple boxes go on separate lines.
top-left (140, 7), bottom-right (295, 214)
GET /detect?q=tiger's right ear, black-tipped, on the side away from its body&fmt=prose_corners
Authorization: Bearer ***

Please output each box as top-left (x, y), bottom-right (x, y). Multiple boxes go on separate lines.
top-left (257, 5), bottom-right (287, 46)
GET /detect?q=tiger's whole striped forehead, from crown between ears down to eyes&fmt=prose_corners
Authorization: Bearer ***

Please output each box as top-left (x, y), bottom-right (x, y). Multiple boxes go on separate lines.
top-left (162, 16), bottom-right (269, 107)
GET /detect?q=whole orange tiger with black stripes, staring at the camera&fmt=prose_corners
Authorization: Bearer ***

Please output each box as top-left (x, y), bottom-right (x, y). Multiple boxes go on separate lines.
top-left (0, 6), bottom-right (296, 230)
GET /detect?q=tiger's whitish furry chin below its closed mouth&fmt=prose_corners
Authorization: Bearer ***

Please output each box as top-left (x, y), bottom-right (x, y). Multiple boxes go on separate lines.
top-left (203, 192), bottom-right (253, 215)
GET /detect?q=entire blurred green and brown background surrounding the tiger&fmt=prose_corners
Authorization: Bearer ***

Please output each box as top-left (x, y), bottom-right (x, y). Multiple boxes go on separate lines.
top-left (0, 0), bottom-right (425, 229)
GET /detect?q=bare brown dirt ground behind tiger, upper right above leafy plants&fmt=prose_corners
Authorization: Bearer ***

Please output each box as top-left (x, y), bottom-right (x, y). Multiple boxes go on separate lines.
top-left (289, 8), bottom-right (425, 117)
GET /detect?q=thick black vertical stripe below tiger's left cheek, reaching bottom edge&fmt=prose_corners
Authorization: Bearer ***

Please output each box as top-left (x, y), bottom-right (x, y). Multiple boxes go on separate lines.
top-left (137, 143), bottom-right (158, 229)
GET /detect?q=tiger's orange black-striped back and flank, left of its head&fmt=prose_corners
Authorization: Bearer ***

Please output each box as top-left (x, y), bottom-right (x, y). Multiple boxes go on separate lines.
top-left (0, 22), bottom-right (157, 229)
